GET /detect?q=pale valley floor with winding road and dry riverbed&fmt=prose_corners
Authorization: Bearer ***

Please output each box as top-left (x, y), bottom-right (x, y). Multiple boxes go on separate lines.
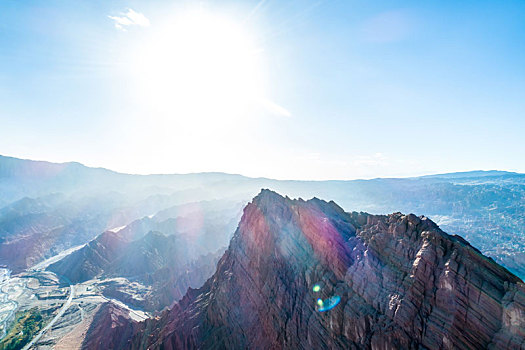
top-left (0, 247), bottom-right (150, 350)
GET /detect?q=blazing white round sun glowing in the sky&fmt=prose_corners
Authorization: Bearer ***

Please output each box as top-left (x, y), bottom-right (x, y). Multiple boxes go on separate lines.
top-left (129, 10), bottom-right (264, 123)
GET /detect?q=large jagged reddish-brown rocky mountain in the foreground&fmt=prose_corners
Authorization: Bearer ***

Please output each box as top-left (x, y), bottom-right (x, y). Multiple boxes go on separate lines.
top-left (100, 190), bottom-right (525, 349)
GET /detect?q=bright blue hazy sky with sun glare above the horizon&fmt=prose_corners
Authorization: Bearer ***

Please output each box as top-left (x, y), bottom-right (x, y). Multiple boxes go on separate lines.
top-left (0, 0), bottom-right (525, 179)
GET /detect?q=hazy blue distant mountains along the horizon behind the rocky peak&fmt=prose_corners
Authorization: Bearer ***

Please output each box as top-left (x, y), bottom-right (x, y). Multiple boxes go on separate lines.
top-left (0, 156), bottom-right (525, 278)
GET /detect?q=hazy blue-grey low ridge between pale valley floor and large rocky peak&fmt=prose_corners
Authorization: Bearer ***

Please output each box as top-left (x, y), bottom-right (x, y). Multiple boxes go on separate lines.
top-left (48, 231), bottom-right (224, 311)
